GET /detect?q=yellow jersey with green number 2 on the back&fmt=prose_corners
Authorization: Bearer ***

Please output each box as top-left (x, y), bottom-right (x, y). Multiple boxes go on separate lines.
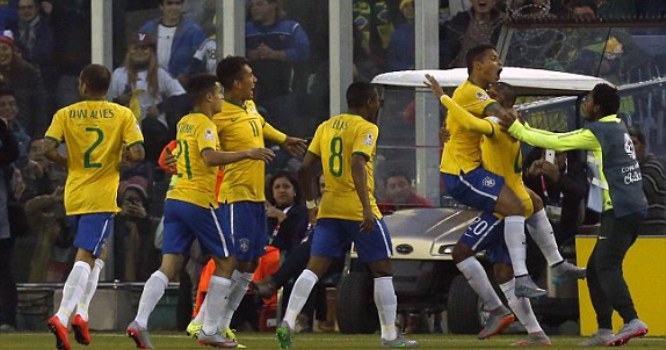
top-left (45, 100), bottom-right (143, 215)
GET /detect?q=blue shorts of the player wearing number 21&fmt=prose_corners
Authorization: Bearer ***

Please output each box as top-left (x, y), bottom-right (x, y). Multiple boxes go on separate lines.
top-left (162, 199), bottom-right (233, 258)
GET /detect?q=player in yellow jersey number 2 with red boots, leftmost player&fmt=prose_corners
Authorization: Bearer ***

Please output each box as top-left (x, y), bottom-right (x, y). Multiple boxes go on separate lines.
top-left (44, 64), bottom-right (144, 350)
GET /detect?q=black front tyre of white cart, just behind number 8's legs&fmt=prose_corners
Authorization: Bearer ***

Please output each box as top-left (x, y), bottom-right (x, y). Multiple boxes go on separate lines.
top-left (337, 271), bottom-right (379, 334)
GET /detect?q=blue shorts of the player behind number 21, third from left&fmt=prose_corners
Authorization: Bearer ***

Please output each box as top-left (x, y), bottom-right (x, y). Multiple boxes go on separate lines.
top-left (220, 202), bottom-right (268, 261)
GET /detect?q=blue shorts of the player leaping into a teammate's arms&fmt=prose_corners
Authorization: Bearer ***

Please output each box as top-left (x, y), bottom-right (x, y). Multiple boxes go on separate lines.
top-left (442, 167), bottom-right (504, 212)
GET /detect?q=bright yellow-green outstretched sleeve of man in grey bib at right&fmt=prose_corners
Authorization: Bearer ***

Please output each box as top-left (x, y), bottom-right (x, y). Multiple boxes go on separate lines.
top-left (507, 121), bottom-right (601, 152)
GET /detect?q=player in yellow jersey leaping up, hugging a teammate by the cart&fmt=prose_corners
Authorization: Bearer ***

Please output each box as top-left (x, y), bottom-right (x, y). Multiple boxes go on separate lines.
top-left (426, 44), bottom-right (546, 297)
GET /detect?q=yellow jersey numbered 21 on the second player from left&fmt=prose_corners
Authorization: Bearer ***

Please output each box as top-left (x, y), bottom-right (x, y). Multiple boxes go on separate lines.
top-left (167, 113), bottom-right (220, 208)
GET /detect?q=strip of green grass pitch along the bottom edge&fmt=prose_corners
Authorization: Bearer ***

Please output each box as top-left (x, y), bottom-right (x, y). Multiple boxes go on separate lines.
top-left (5, 332), bottom-right (666, 350)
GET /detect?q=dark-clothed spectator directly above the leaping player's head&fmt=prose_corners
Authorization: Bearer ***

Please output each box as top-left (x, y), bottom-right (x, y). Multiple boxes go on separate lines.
top-left (439, 0), bottom-right (506, 68)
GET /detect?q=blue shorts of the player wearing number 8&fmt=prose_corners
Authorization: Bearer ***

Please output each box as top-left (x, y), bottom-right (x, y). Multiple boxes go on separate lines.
top-left (310, 219), bottom-right (393, 262)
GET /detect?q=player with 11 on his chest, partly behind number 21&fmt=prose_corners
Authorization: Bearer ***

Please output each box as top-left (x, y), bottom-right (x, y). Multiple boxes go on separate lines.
top-left (204, 56), bottom-right (306, 336)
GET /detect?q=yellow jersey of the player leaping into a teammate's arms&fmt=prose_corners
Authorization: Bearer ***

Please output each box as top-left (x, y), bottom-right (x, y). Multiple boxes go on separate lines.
top-left (439, 80), bottom-right (495, 176)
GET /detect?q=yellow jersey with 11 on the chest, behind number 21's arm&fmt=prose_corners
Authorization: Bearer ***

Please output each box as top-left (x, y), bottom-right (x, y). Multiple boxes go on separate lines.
top-left (213, 100), bottom-right (287, 203)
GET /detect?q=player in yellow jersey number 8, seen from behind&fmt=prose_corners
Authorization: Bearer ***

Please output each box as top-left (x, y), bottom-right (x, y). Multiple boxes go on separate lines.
top-left (277, 82), bottom-right (418, 349)
